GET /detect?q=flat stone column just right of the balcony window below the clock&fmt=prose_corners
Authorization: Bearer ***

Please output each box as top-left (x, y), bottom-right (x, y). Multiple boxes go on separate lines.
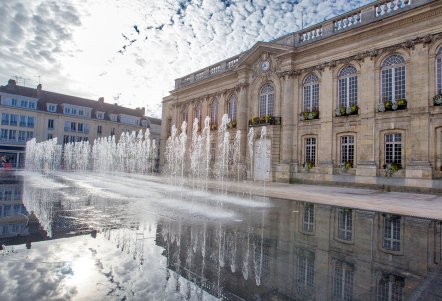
top-left (275, 74), bottom-right (294, 182)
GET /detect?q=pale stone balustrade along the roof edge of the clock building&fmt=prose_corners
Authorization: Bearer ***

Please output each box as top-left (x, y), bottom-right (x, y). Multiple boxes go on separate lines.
top-left (175, 0), bottom-right (432, 89)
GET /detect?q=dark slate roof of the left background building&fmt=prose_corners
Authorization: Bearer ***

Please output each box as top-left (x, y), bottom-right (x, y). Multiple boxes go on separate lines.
top-left (0, 80), bottom-right (148, 120)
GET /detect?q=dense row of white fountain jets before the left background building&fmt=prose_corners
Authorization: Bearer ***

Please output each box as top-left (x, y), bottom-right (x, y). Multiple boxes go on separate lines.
top-left (25, 129), bottom-right (157, 174)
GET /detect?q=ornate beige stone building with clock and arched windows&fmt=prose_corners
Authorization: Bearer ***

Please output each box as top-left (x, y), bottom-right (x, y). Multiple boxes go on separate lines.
top-left (162, 0), bottom-right (442, 187)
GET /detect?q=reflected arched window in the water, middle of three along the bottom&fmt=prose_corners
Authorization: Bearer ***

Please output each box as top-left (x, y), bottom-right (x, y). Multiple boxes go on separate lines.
top-left (332, 260), bottom-right (353, 301)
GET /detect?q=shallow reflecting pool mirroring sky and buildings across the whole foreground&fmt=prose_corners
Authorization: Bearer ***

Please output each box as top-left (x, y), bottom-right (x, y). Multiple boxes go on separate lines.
top-left (0, 172), bottom-right (442, 301)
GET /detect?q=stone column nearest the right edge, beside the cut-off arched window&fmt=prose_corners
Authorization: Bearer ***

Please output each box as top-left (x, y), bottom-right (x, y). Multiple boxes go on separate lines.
top-left (403, 44), bottom-right (434, 179)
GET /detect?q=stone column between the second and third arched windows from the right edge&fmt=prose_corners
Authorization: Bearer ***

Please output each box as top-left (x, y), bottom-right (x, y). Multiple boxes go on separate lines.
top-left (355, 58), bottom-right (378, 177)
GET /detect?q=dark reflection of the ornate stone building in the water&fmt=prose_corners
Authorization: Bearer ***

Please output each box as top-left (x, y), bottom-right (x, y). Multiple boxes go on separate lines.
top-left (157, 200), bottom-right (442, 300)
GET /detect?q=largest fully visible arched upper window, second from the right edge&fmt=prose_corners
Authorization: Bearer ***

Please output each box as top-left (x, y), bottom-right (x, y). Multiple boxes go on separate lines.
top-left (381, 54), bottom-right (406, 102)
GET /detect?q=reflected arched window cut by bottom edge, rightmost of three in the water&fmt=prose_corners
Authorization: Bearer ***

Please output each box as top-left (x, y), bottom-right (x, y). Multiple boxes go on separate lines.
top-left (377, 274), bottom-right (405, 301)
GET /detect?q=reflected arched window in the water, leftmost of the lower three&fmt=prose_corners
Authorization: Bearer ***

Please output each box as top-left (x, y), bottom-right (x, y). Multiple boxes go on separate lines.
top-left (296, 249), bottom-right (315, 290)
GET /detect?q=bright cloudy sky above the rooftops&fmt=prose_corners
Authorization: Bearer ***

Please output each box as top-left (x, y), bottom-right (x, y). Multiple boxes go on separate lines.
top-left (0, 0), bottom-right (370, 116)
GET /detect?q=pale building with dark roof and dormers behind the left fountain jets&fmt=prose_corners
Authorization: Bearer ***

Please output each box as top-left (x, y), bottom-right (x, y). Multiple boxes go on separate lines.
top-left (0, 79), bottom-right (161, 167)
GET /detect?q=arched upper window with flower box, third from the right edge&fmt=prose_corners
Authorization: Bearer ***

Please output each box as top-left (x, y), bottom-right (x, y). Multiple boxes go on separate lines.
top-left (339, 66), bottom-right (358, 108)
